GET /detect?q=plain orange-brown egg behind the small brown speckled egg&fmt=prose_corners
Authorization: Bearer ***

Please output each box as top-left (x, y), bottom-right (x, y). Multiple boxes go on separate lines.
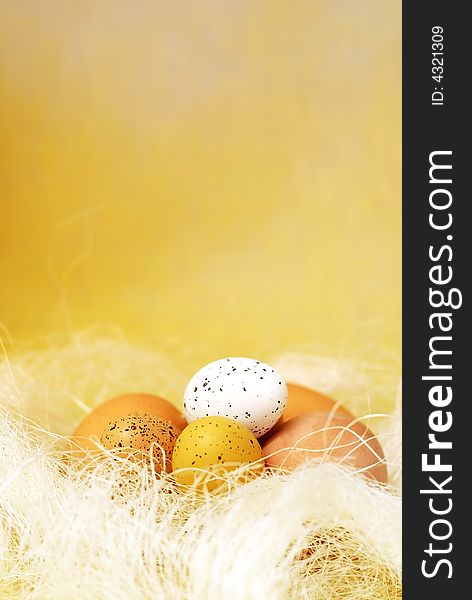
top-left (72, 394), bottom-right (187, 450)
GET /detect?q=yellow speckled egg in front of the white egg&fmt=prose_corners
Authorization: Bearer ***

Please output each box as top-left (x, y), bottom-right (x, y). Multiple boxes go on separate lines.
top-left (172, 416), bottom-right (264, 491)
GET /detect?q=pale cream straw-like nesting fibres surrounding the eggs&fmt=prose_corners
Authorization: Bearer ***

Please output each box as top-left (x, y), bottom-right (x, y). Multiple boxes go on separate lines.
top-left (0, 333), bottom-right (401, 600)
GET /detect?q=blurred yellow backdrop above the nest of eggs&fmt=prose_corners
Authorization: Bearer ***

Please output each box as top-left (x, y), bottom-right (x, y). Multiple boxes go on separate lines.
top-left (0, 0), bottom-right (401, 367)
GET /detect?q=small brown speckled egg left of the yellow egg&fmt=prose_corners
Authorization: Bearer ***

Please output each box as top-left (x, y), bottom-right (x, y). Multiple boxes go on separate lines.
top-left (100, 412), bottom-right (180, 473)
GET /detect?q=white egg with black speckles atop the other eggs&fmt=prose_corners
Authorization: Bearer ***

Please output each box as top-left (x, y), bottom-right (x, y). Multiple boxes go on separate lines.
top-left (184, 357), bottom-right (287, 437)
